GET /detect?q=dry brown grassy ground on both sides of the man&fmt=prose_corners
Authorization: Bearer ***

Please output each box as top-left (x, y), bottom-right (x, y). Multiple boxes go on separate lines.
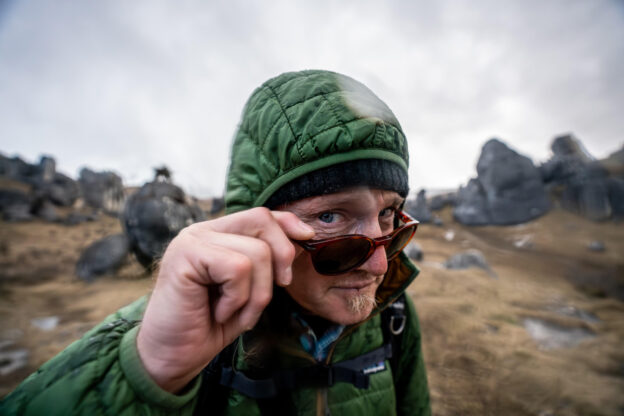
top-left (0, 209), bottom-right (624, 416)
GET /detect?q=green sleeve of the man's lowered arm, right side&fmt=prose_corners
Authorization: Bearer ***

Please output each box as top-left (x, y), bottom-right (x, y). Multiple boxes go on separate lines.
top-left (395, 295), bottom-right (431, 416)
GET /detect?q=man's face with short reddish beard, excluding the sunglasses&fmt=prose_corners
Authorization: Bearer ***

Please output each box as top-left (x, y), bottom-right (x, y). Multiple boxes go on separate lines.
top-left (280, 187), bottom-right (403, 325)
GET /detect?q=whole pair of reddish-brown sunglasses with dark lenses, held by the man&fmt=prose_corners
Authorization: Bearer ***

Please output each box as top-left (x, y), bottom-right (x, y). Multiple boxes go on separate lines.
top-left (295, 211), bottom-right (418, 276)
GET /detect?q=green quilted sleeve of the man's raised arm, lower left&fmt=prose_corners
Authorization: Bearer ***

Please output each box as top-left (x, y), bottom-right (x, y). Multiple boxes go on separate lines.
top-left (0, 297), bottom-right (201, 415)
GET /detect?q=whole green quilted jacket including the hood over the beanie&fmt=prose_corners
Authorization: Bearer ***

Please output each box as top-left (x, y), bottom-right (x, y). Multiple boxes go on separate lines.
top-left (0, 71), bottom-right (430, 416)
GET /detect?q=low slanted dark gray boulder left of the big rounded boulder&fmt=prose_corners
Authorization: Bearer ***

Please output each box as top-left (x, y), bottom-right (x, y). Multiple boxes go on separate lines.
top-left (76, 234), bottom-right (130, 282)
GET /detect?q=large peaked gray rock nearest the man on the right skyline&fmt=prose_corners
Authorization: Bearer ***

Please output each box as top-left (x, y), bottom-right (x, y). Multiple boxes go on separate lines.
top-left (453, 139), bottom-right (550, 225)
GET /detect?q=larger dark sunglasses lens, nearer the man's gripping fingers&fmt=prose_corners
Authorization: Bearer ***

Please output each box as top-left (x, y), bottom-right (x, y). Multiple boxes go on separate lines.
top-left (312, 238), bottom-right (371, 274)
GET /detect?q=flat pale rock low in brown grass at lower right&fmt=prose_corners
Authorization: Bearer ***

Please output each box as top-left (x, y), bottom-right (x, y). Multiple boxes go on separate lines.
top-left (523, 318), bottom-right (595, 350)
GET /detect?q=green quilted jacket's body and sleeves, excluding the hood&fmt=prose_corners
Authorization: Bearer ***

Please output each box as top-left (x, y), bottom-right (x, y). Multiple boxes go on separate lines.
top-left (0, 256), bottom-right (431, 416)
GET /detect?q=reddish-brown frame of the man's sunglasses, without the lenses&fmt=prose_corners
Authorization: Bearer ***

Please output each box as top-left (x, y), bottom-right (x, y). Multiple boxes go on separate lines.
top-left (293, 211), bottom-right (419, 276)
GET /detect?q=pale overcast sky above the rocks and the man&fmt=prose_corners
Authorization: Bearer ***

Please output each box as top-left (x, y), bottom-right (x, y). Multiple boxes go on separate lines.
top-left (0, 0), bottom-right (624, 196)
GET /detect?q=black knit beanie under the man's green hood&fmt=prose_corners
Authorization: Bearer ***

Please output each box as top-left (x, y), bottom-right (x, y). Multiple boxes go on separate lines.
top-left (264, 159), bottom-right (409, 209)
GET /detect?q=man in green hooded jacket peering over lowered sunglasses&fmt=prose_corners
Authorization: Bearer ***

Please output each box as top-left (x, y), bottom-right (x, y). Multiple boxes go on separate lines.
top-left (4, 71), bottom-right (430, 415)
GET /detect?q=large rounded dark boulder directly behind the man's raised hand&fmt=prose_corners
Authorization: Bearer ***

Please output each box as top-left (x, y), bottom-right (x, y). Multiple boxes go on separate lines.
top-left (122, 181), bottom-right (204, 269)
